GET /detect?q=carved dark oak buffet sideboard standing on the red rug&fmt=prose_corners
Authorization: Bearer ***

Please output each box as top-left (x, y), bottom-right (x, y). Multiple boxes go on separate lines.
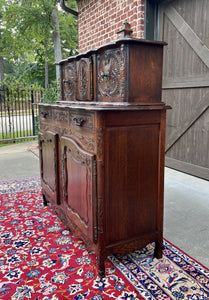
top-left (39, 24), bottom-right (170, 277)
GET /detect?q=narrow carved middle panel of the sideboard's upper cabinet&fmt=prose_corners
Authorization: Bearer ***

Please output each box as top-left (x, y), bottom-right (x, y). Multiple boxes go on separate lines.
top-left (76, 58), bottom-right (93, 101)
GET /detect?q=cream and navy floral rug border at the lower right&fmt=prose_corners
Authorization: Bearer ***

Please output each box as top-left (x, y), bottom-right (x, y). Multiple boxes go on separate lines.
top-left (110, 240), bottom-right (209, 300)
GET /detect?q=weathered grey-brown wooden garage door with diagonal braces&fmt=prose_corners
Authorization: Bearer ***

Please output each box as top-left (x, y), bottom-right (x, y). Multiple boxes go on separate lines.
top-left (159, 0), bottom-right (209, 180)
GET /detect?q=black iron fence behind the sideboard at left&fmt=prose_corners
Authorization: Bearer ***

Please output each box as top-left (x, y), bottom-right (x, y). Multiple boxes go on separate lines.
top-left (0, 88), bottom-right (42, 143)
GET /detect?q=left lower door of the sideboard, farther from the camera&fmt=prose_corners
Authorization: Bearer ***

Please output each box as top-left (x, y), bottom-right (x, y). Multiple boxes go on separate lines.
top-left (39, 131), bottom-right (59, 204)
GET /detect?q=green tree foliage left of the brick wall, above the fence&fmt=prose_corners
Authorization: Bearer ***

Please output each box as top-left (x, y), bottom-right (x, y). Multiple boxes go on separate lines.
top-left (0, 0), bottom-right (78, 87)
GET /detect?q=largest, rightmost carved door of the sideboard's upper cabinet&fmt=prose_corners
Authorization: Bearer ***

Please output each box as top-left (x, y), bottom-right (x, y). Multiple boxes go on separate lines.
top-left (97, 46), bottom-right (127, 102)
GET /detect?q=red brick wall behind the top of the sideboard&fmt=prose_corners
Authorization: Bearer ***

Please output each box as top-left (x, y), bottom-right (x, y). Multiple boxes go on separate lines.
top-left (78, 0), bottom-right (145, 53)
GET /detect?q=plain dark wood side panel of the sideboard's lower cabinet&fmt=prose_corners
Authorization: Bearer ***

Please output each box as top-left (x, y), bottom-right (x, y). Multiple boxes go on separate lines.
top-left (105, 124), bottom-right (159, 245)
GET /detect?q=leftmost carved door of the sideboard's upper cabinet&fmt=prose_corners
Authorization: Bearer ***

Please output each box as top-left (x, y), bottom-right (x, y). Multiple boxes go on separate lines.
top-left (61, 62), bottom-right (76, 101)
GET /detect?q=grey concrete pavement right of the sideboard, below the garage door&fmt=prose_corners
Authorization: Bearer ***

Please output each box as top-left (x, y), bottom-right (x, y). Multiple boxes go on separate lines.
top-left (164, 168), bottom-right (209, 268)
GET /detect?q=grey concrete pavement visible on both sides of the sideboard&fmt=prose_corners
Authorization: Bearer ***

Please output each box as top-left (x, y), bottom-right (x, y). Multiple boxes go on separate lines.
top-left (0, 142), bottom-right (209, 268)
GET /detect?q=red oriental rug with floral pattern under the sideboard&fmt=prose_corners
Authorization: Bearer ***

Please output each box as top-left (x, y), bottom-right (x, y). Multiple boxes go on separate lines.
top-left (0, 178), bottom-right (209, 300)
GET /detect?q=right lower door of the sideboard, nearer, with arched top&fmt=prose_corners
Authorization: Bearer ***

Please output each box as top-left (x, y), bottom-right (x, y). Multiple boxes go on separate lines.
top-left (61, 137), bottom-right (97, 242)
